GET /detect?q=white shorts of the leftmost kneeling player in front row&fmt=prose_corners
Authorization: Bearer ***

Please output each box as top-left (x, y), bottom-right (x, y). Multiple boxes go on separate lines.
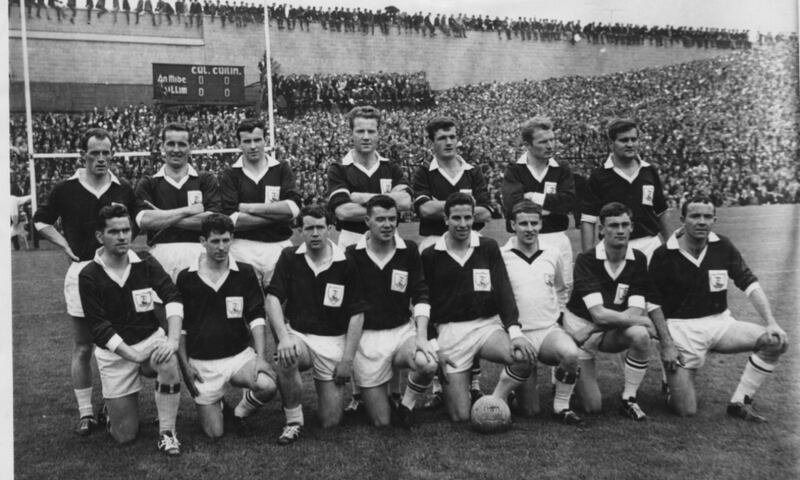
top-left (94, 328), bottom-right (167, 398)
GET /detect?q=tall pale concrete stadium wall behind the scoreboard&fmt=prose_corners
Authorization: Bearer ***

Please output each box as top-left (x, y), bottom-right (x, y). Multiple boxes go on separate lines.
top-left (9, 7), bottom-right (728, 111)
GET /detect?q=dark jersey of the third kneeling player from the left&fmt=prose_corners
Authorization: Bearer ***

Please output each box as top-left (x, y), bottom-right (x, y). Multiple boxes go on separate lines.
top-left (267, 243), bottom-right (367, 336)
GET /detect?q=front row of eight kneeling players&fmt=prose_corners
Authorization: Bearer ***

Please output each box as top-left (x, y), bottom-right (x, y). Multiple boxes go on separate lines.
top-left (79, 192), bottom-right (788, 455)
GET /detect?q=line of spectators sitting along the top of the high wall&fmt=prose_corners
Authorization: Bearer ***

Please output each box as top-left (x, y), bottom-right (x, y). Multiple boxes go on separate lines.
top-left (9, 0), bottom-right (786, 48)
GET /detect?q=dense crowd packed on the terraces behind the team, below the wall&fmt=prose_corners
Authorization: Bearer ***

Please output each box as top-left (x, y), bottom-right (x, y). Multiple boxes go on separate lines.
top-left (11, 42), bottom-right (800, 219)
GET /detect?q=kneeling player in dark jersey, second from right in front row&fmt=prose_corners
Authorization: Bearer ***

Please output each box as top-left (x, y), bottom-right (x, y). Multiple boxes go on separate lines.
top-left (564, 202), bottom-right (674, 421)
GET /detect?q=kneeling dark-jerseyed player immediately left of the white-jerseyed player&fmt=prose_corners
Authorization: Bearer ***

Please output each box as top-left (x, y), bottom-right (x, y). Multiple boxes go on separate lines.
top-left (422, 192), bottom-right (533, 422)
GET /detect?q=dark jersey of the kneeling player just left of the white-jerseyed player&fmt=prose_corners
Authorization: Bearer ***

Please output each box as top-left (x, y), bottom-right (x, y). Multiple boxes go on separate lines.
top-left (422, 232), bottom-right (519, 328)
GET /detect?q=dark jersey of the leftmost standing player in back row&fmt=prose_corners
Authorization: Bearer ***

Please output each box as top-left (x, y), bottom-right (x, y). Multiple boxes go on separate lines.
top-left (33, 172), bottom-right (140, 261)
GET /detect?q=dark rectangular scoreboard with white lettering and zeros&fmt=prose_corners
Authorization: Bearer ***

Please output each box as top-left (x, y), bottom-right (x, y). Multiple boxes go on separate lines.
top-left (153, 63), bottom-right (244, 104)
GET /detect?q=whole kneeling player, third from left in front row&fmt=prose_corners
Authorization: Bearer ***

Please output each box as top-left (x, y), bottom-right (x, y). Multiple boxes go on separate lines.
top-left (267, 206), bottom-right (367, 445)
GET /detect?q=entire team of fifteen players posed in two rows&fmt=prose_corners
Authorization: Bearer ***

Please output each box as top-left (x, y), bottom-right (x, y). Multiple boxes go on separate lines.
top-left (34, 107), bottom-right (788, 455)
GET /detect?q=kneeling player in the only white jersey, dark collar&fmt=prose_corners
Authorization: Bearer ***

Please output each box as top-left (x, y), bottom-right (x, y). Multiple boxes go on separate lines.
top-left (501, 200), bottom-right (582, 425)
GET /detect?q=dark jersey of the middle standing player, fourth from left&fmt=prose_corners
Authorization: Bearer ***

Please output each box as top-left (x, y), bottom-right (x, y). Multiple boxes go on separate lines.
top-left (328, 152), bottom-right (411, 233)
